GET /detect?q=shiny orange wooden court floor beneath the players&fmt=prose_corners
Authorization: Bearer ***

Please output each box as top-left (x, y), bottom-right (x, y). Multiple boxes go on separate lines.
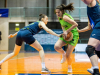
top-left (0, 53), bottom-right (100, 75)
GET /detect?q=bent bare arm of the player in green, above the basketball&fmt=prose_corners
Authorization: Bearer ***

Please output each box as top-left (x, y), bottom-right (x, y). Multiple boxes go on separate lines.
top-left (63, 15), bottom-right (78, 33)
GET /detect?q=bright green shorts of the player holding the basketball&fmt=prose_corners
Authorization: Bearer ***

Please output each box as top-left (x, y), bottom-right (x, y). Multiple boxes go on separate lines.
top-left (59, 35), bottom-right (79, 46)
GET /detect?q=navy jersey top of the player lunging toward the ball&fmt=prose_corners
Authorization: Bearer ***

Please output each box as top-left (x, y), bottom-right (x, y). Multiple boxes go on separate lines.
top-left (22, 21), bottom-right (41, 35)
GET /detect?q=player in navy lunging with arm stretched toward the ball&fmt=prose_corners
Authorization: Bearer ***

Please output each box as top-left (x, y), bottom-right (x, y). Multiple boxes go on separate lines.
top-left (0, 14), bottom-right (60, 72)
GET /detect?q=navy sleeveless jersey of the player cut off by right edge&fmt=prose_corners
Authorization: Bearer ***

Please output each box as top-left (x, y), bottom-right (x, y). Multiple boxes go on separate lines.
top-left (87, 2), bottom-right (100, 29)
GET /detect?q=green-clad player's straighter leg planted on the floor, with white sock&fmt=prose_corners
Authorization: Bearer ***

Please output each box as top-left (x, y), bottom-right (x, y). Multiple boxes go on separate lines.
top-left (66, 44), bottom-right (75, 72)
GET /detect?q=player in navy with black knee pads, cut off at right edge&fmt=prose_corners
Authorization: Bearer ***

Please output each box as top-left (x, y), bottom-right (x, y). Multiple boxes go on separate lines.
top-left (78, 0), bottom-right (100, 75)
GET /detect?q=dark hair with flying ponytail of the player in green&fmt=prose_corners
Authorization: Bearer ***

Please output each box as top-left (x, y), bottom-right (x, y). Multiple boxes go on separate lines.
top-left (56, 3), bottom-right (74, 12)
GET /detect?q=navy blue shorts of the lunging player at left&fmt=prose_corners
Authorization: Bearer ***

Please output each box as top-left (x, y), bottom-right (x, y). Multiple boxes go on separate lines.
top-left (16, 30), bottom-right (35, 46)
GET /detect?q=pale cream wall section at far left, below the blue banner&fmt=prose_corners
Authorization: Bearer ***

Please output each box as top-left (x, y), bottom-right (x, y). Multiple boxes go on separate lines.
top-left (0, 18), bottom-right (8, 50)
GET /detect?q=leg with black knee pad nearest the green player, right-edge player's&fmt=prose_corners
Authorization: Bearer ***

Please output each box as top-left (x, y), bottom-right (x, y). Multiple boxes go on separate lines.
top-left (86, 38), bottom-right (99, 74)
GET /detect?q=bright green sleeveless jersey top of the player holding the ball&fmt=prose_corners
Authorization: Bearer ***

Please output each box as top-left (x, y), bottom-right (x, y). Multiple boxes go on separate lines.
top-left (59, 13), bottom-right (79, 35)
